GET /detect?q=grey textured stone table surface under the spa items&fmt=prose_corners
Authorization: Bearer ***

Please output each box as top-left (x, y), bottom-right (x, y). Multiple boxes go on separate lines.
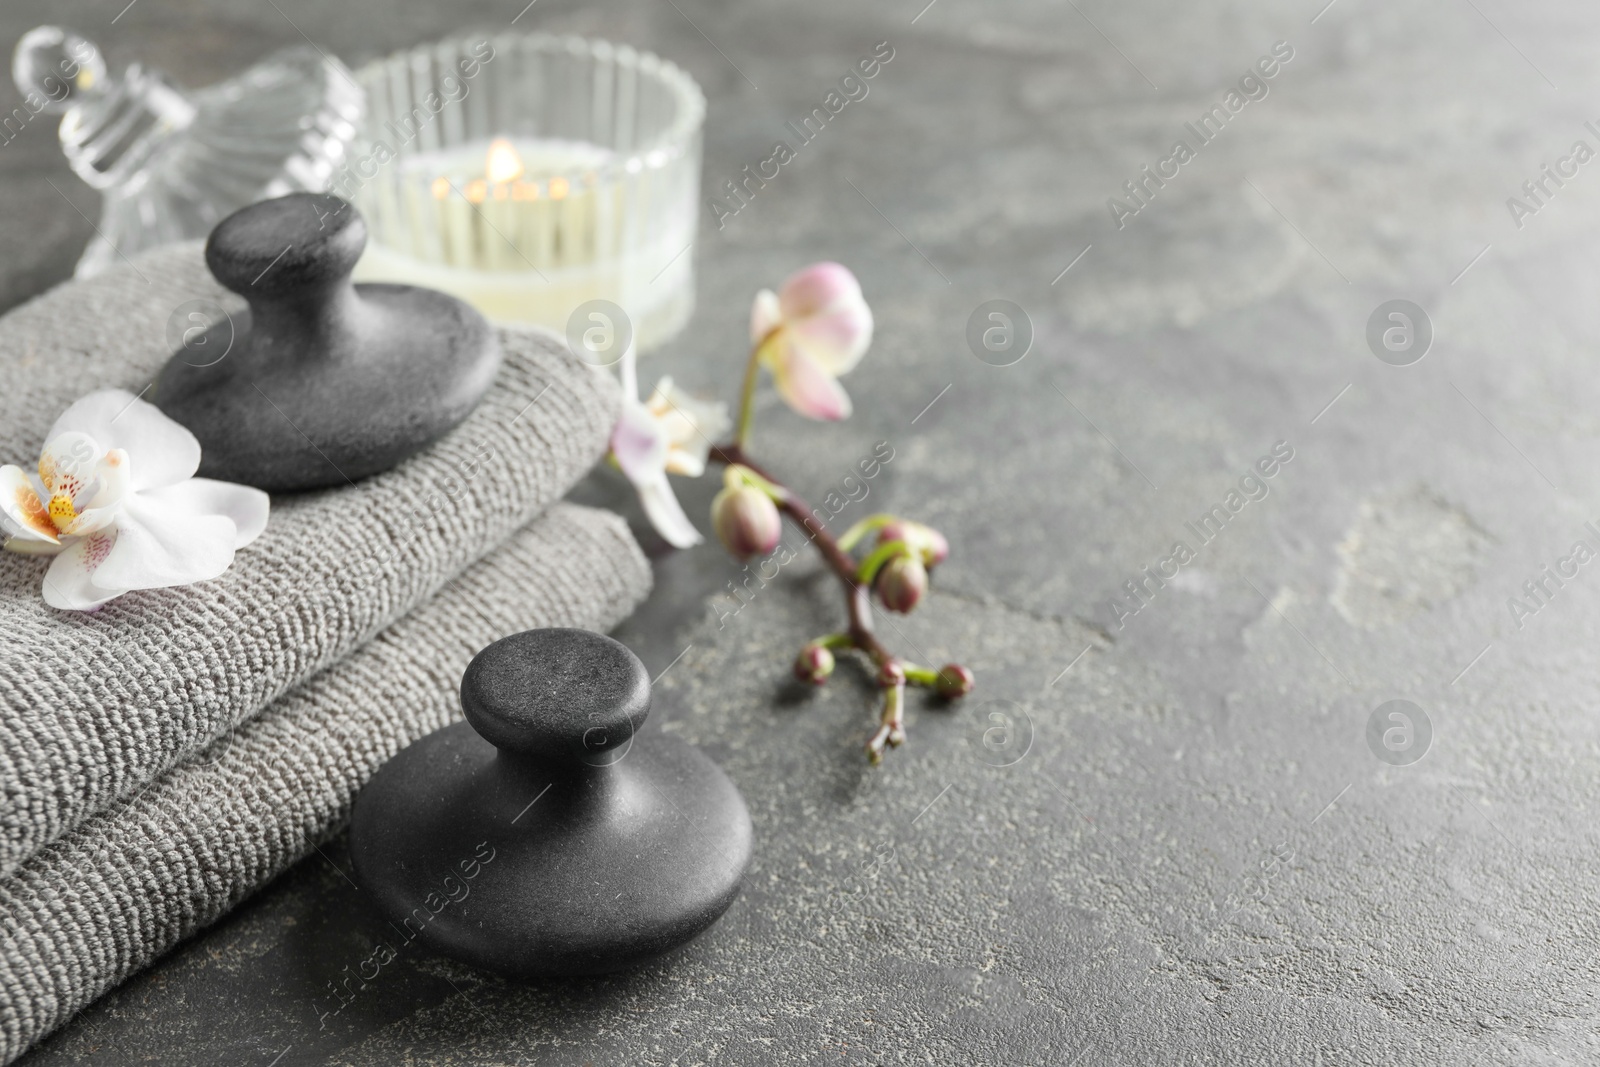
top-left (0, 0), bottom-right (1600, 1067)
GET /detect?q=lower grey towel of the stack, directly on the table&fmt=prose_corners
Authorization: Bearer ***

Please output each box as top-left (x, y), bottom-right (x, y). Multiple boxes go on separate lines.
top-left (0, 504), bottom-right (650, 1062)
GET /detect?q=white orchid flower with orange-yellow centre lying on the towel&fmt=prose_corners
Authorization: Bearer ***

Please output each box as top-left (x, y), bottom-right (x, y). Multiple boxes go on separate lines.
top-left (0, 389), bottom-right (269, 611)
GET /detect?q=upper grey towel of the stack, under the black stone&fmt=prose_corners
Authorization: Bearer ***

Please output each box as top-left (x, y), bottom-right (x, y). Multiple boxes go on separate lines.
top-left (0, 245), bottom-right (618, 877)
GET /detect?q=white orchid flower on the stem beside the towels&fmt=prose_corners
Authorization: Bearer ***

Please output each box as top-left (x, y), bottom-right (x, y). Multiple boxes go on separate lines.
top-left (611, 346), bottom-right (733, 549)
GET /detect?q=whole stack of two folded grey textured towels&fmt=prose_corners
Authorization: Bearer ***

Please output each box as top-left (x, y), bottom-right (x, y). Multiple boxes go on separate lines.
top-left (0, 246), bottom-right (650, 1062)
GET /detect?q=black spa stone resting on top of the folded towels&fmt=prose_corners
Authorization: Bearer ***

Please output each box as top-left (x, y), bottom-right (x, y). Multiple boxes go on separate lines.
top-left (150, 194), bottom-right (501, 493)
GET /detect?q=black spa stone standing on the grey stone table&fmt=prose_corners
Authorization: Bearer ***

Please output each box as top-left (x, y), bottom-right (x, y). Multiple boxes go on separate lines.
top-left (350, 629), bottom-right (750, 977)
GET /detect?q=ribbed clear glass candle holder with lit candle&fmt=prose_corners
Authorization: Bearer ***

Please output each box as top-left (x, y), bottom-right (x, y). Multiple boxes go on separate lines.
top-left (347, 34), bottom-right (706, 350)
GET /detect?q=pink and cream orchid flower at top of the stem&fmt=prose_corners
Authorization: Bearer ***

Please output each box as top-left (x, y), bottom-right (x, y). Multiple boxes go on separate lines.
top-left (750, 262), bottom-right (872, 421)
